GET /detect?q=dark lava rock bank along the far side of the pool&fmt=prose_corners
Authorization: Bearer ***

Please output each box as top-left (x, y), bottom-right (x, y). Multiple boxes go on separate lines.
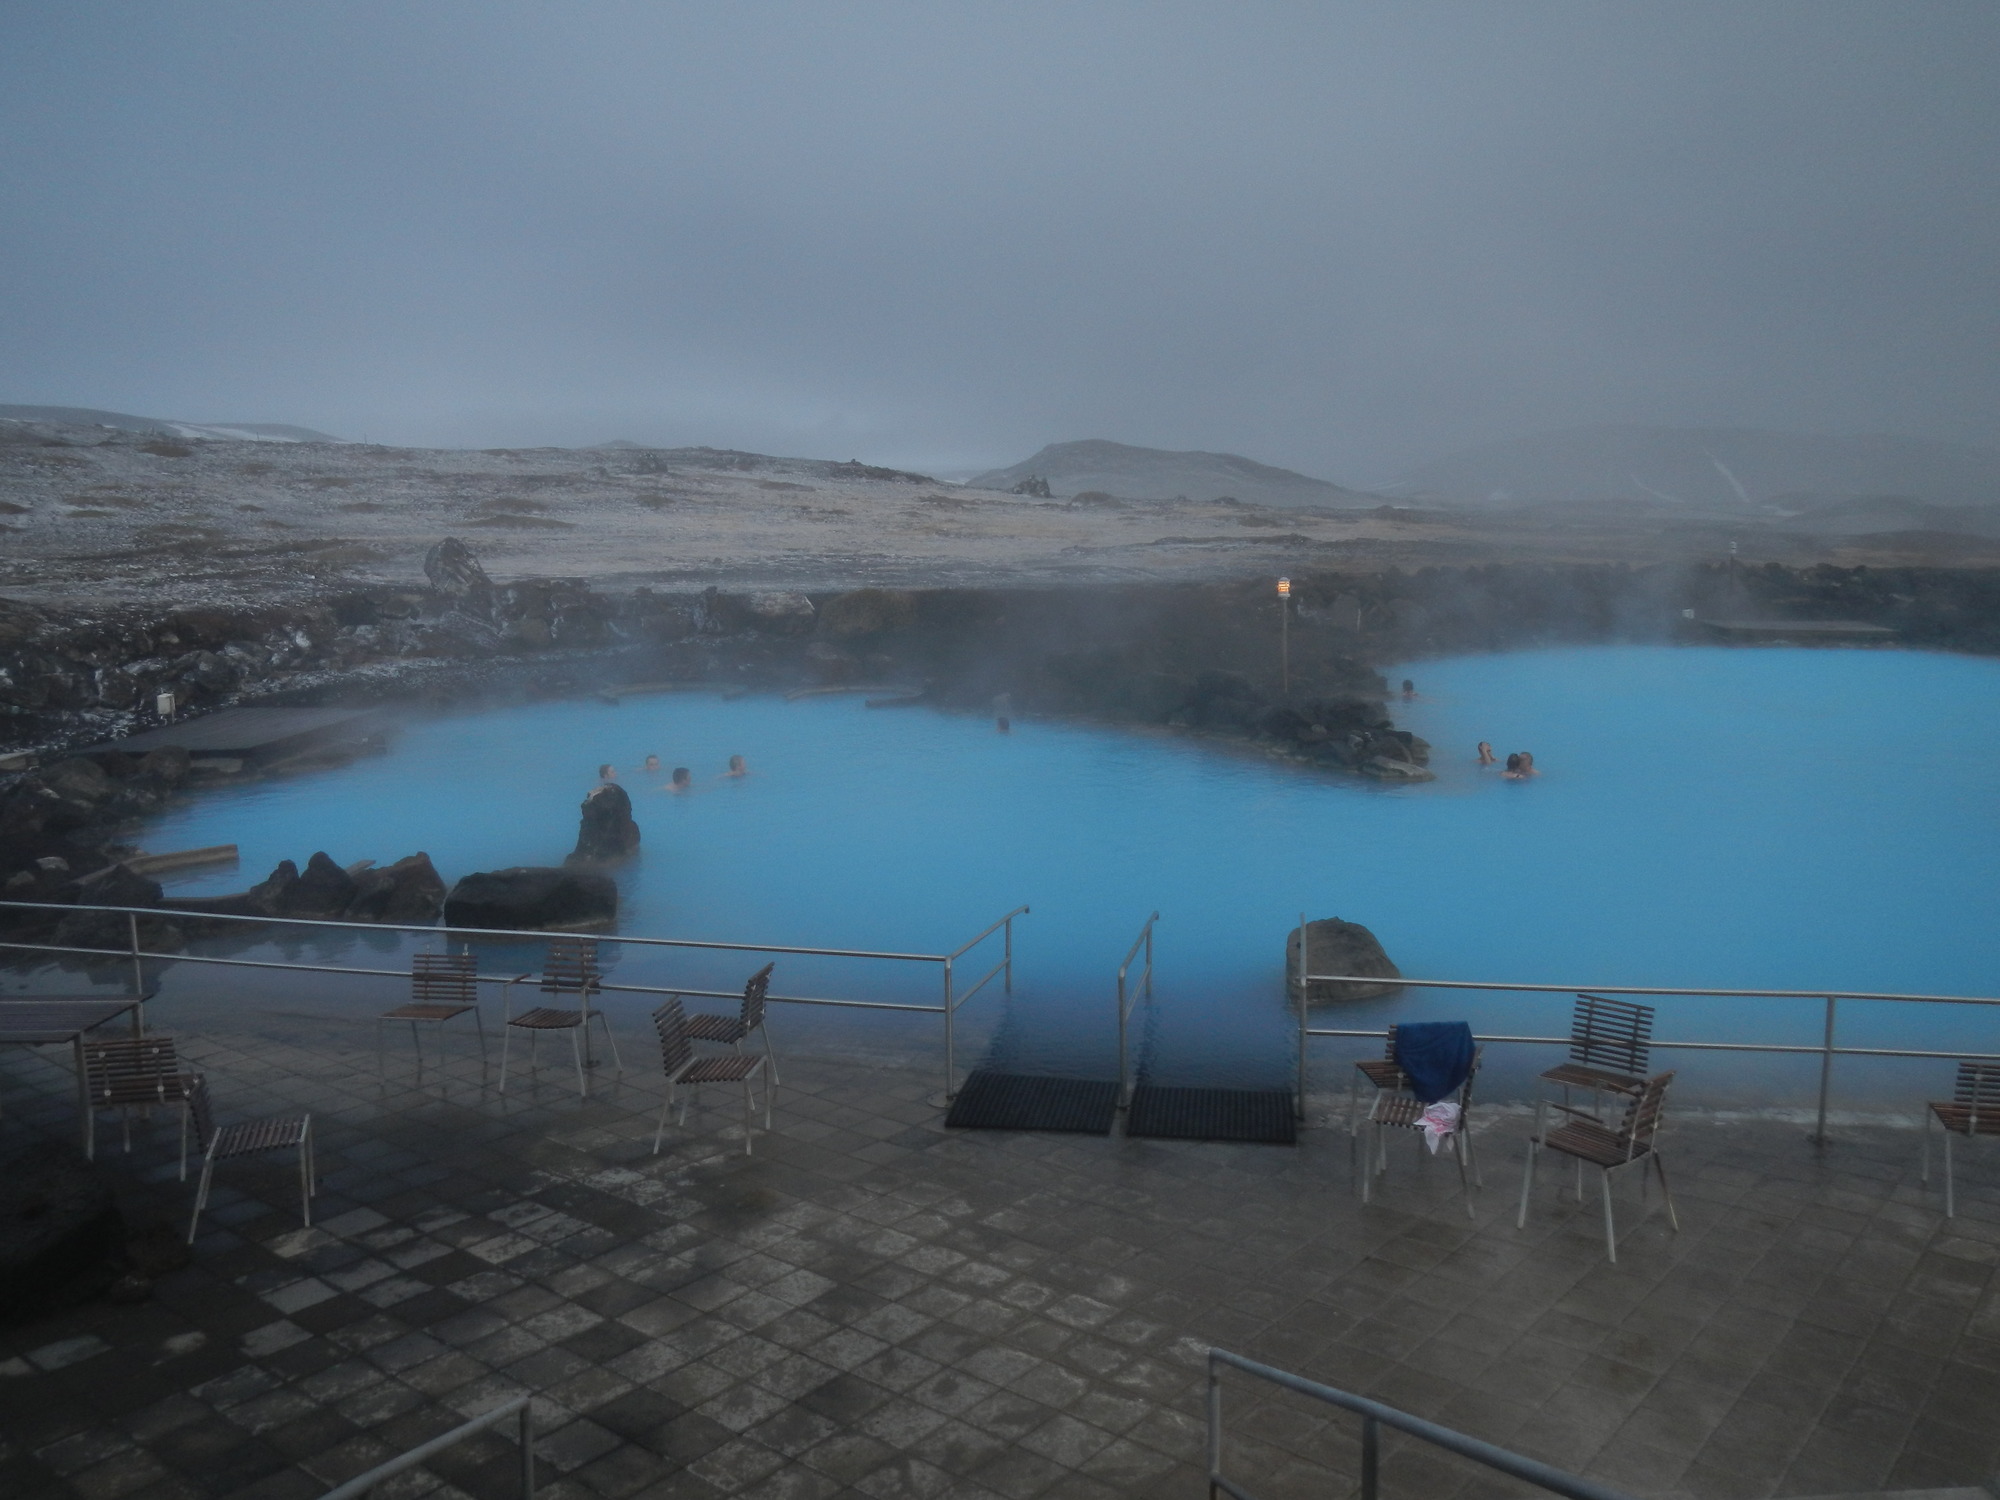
top-left (11, 538), bottom-right (2000, 914)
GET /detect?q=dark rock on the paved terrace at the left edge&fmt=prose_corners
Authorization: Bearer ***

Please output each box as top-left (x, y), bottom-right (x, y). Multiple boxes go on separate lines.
top-left (0, 1140), bottom-right (124, 1322)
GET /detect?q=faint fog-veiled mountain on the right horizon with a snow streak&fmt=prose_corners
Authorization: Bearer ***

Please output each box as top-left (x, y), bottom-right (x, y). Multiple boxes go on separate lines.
top-left (1384, 426), bottom-right (2000, 510)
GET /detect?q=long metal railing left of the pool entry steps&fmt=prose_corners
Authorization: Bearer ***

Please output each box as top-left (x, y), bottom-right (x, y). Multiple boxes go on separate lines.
top-left (0, 900), bottom-right (1028, 1096)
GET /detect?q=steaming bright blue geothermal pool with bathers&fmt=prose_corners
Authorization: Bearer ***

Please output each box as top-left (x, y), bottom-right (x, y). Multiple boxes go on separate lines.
top-left (121, 646), bottom-right (2000, 1106)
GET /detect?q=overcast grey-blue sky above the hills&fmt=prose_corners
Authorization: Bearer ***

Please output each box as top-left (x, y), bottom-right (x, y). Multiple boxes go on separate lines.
top-left (0, 0), bottom-right (2000, 482)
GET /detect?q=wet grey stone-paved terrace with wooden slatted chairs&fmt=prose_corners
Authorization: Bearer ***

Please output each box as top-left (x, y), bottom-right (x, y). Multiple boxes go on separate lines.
top-left (0, 1028), bottom-right (2000, 1500)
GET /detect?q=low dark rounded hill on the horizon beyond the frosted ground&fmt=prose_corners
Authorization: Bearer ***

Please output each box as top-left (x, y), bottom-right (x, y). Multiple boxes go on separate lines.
top-left (970, 438), bottom-right (1374, 508)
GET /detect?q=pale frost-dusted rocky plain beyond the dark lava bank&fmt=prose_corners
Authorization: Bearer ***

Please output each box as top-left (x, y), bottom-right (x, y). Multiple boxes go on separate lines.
top-left (0, 422), bottom-right (1472, 606)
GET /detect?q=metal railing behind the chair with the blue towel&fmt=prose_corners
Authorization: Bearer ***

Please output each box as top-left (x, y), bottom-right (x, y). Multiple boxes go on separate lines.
top-left (1292, 968), bottom-right (2000, 1144)
